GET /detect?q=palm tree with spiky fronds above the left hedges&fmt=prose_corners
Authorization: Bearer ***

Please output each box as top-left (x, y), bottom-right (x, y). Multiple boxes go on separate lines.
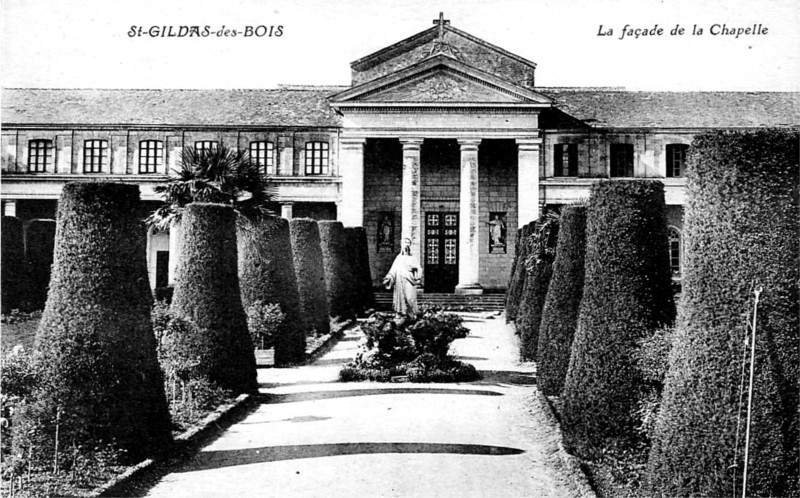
top-left (147, 146), bottom-right (276, 230)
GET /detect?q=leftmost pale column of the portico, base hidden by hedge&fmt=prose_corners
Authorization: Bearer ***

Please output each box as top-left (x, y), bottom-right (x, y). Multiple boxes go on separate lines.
top-left (337, 138), bottom-right (365, 227)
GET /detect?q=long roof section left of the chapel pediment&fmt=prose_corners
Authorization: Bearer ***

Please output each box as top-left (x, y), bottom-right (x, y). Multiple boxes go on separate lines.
top-left (2, 86), bottom-right (346, 127)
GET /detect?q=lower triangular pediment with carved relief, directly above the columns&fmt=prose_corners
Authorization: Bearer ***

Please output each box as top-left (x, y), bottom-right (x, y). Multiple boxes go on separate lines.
top-left (331, 54), bottom-right (552, 106)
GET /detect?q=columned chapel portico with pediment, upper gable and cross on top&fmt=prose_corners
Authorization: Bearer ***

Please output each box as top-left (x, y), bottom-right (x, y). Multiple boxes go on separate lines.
top-left (331, 18), bottom-right (552, 294)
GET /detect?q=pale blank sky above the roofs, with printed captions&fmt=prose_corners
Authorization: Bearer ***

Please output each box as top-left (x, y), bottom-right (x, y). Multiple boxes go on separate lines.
top-left (0, 0), bottom-right (800, 91)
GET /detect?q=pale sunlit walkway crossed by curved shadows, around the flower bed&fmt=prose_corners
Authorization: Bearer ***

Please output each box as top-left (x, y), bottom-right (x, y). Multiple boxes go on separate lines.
top-left (142, 313), bottom-right (585, 498)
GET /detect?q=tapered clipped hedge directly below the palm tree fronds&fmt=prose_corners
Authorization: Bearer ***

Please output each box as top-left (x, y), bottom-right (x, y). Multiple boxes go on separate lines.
top-left (172, 203), bottom-right (257, 392)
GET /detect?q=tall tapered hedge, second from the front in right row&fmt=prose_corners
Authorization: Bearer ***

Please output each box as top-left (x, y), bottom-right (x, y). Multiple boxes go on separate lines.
top-left (562, 180), bottom-right (675, 447)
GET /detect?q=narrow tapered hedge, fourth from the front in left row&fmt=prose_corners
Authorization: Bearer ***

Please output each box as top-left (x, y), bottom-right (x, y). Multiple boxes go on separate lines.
top-left (289, 218), bottom-right (331, 334)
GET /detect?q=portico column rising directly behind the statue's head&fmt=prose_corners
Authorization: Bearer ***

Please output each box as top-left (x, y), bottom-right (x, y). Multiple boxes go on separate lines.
top-left (400, 138), bottom-right (424, 268)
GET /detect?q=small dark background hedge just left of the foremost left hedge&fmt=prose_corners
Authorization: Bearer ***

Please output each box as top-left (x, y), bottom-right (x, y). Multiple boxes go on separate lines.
top-left (25, 220), bottom-right (56, 309)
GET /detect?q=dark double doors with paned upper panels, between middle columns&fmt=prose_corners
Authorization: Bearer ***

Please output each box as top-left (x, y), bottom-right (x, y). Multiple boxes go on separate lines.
top-left (425, 212), bottom-right (458, 293)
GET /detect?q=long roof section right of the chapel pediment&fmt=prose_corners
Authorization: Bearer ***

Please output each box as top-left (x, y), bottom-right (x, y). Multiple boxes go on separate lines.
top-left (534, 87), bottom-right (800, 128)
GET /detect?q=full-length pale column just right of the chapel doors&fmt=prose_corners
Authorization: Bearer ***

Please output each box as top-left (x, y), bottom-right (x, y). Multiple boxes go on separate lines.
top-left (456, 138), bottom-right (483, 294)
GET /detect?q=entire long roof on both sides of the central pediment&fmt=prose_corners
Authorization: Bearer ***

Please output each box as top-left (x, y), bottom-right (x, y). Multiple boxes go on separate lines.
top-left (0, 86), bottom-right (800, 128)
